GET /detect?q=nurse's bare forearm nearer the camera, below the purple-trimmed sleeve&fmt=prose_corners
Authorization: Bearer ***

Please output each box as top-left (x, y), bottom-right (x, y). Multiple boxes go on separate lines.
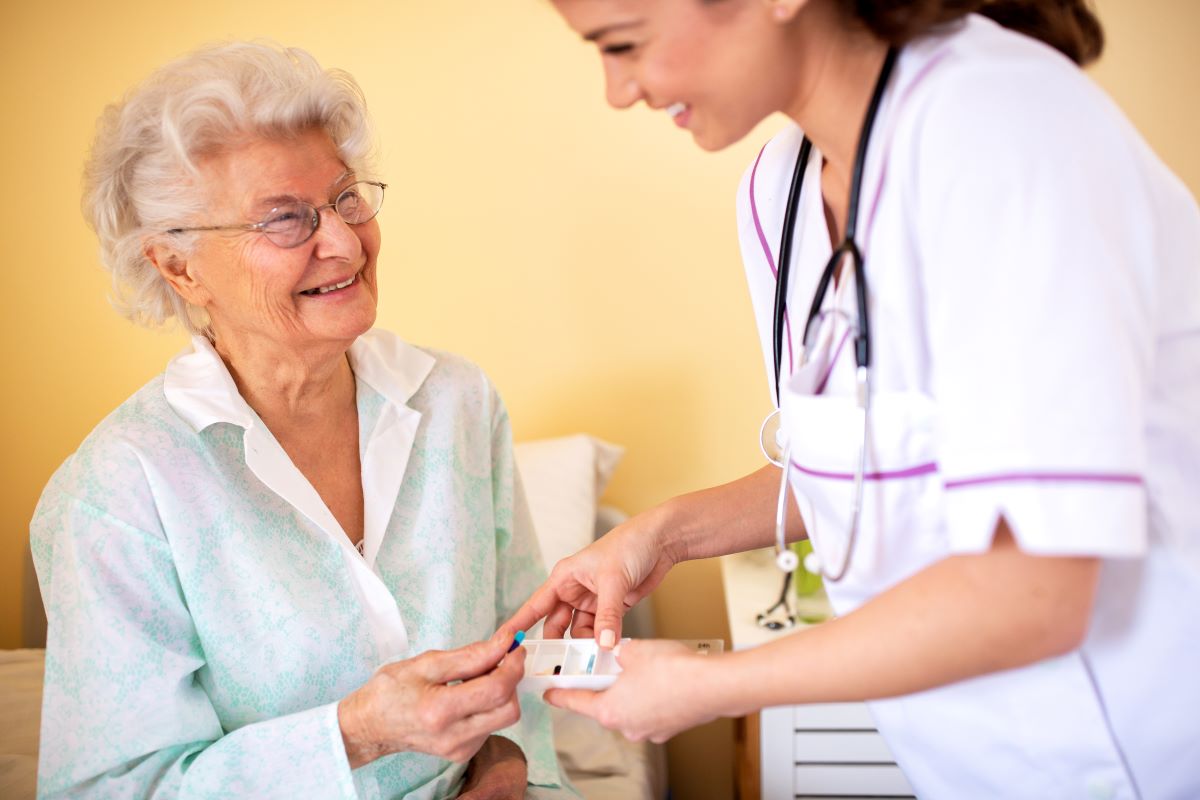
top-left (721, 524), bottom-right (1099, 715)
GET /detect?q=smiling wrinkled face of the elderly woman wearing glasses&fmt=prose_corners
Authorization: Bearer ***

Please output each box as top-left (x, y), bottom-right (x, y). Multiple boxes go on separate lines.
top-left (180, 131), bottom-right (379, 349)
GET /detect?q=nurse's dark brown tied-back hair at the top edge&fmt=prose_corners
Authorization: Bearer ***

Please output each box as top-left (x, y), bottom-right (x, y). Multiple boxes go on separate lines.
top-left (836, 0), bottom-right (1104, 66)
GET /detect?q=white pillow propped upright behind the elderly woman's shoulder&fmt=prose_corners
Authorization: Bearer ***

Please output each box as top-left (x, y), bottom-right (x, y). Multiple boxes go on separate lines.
top-left (514, 433), bottom-right (624, 570)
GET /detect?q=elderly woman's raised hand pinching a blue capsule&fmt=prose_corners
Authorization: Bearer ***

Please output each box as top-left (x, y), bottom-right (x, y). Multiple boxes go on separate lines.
top-left (337, 636), bottom-right (524, 769)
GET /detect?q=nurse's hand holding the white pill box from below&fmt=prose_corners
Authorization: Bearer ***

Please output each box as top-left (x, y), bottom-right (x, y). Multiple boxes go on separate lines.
top-left (545, 639), bottom-right (720, 742)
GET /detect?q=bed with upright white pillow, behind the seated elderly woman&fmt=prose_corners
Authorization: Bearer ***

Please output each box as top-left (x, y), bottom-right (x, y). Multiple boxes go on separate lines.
top-left (0, 435), bottom-right (667, 800)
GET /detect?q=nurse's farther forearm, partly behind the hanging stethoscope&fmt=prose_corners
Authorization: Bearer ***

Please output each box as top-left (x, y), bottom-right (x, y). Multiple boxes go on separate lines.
top-left (649, 464), bottom-right (804, 560)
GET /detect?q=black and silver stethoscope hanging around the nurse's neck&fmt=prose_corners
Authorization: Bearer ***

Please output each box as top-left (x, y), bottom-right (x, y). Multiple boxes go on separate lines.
top-left (757, 47), bottom-right (900, 630)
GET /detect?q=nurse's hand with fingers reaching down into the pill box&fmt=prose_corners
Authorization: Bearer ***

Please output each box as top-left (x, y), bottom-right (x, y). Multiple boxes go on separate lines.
top-left (500, 509), bottom-right (683, 648)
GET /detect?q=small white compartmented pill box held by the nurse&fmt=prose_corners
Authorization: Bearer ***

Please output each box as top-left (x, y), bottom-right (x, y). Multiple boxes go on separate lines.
top-left (517, 638), bottom-right (725, 694)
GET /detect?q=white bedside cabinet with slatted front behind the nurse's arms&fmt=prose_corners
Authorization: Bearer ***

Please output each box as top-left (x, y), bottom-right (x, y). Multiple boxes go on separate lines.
top-left (721, 549), bottom-right (914, 800)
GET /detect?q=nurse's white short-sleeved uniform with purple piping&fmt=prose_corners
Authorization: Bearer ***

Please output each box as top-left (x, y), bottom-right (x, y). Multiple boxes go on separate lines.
top-left (738, 17), bottom-right (1200, 798)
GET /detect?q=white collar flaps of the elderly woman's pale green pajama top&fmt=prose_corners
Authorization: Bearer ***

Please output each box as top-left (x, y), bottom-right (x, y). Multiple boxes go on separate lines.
top-left (163, 329), bottom-right (437, 433)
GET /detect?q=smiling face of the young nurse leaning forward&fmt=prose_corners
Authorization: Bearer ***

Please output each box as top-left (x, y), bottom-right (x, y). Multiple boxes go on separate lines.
top-left (554, 0), bottom-right (804, 150)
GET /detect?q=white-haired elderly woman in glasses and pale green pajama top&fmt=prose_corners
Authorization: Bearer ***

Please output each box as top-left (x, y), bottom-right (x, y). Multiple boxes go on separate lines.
top-left (31, 43), bottom-right (575, 798)
